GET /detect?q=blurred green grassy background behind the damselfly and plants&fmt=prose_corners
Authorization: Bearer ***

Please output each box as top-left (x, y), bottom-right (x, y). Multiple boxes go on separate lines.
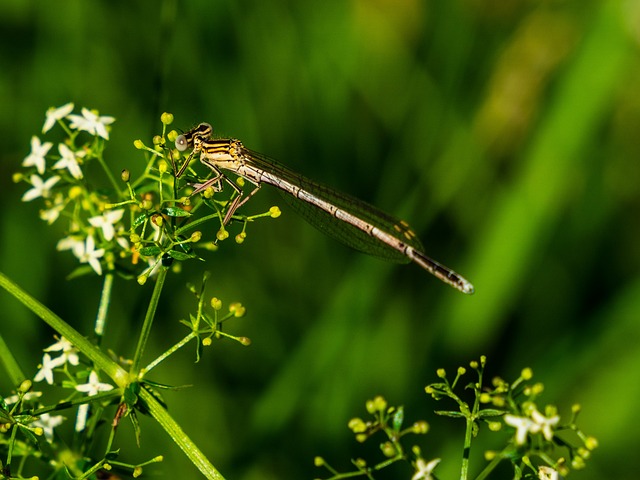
top-left (0, 0), bottom-right (640, 480)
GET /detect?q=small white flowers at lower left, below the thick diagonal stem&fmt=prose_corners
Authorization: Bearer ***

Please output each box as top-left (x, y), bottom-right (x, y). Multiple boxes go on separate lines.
top-left (30, 337), bottom-right (113, 440)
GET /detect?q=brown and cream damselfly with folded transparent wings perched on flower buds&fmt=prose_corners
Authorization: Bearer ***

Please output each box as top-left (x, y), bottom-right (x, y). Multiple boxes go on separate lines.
top-left (175, 123), bottom-right (473, 293)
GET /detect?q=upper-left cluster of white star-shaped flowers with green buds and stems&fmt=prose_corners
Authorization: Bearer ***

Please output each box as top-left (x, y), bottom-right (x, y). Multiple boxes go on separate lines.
top-left (16, 103), bottom-right (124, 275)
